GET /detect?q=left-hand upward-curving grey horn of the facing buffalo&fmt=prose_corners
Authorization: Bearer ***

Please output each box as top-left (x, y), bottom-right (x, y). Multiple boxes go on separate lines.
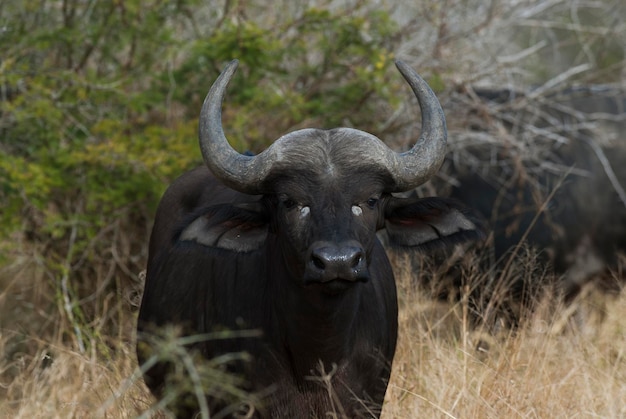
top-left (199, 60), bottom-right (271, 194)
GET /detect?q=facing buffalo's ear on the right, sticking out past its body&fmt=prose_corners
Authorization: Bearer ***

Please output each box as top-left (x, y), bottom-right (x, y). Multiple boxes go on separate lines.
top-left (385, 197), bottom-right (484, 248)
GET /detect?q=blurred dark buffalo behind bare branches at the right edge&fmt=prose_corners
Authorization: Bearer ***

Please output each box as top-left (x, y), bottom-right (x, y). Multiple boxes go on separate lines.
top-left (444, 86), bottom-right (626, 301)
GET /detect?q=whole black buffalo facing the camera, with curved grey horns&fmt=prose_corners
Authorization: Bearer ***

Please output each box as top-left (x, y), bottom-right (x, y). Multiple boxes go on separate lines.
top-left (138, 63), bottom-right (481, 418)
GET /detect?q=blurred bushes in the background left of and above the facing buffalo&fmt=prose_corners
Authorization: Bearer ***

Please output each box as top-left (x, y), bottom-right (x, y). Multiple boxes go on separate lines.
top-left (0, 0), bottom-right (626, 416)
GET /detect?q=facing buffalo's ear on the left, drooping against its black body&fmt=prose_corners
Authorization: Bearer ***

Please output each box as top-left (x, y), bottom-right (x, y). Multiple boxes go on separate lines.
top-left (179, 203), bottom-right (269, 252)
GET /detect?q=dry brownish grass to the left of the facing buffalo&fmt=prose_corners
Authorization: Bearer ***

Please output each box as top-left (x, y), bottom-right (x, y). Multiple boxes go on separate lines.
top-left (0, 249), bottom-right (153, 419)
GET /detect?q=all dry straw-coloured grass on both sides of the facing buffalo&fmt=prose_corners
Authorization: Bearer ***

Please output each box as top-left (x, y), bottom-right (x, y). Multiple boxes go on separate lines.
top-left (0, 253), bottom-right (626, 418)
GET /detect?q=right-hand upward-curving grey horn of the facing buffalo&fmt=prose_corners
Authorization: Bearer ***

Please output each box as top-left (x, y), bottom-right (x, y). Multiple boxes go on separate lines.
top-left (390, 60), bottom-right (448, 192)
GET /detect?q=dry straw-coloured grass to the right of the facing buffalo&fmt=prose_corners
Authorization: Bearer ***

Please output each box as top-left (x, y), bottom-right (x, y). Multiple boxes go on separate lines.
top-left (383, 260), bottom-right (626, 418)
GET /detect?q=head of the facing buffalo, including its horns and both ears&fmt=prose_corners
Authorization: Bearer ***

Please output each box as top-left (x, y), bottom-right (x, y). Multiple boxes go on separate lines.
top-left (181, 61), bottom-right (479, 294)
